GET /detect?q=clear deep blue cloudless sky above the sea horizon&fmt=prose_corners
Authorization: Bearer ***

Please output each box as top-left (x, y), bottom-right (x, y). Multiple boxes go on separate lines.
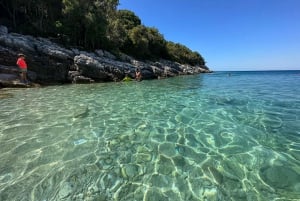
top-left (118, 0), bottom-right (300, 71)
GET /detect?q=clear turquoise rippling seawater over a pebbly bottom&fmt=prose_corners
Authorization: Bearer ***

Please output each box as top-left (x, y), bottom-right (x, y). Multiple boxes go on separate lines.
top-left (0, 71), bottom-right (300, 201)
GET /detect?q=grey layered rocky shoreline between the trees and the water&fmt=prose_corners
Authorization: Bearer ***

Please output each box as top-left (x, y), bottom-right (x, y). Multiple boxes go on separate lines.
top-left (0, 25), bottom-right (211, 88)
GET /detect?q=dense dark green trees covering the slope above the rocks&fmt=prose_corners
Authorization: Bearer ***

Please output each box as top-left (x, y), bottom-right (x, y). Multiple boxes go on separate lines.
top-left (0, 0), bottom-right (205, 65)
